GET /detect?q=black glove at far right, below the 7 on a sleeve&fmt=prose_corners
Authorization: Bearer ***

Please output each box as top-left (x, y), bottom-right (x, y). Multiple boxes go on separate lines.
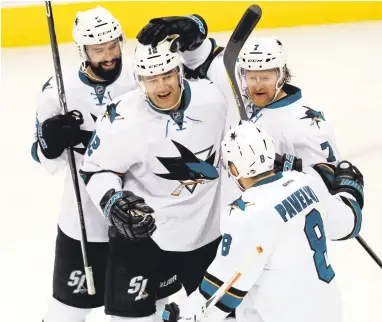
top-left (313, 161), bottom-right (364, 209)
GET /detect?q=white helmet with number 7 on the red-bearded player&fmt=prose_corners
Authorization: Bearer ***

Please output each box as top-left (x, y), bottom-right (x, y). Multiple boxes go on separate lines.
top-left (237, 36), bottom-right (286, 103)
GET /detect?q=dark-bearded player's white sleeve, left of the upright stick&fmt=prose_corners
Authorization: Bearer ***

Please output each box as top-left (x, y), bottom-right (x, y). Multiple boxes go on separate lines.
top-left (31, 77), bottom-right (67, 174)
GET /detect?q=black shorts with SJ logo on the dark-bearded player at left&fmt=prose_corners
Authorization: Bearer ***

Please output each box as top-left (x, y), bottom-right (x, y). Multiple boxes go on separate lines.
top-left (53, 227), bottom-right (109, 309)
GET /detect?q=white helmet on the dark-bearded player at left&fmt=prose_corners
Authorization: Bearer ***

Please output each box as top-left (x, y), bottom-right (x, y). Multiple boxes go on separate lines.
top-left (73, 6), bottom-right (124, 68)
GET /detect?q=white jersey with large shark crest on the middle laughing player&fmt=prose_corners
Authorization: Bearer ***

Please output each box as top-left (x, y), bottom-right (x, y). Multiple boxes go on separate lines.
top-left (81, 80), bottom-right (227, 251)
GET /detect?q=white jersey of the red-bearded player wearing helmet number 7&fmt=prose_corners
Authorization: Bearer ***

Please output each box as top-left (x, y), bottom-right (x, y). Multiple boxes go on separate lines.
top-left (183, 39), bottom-right (340, 200)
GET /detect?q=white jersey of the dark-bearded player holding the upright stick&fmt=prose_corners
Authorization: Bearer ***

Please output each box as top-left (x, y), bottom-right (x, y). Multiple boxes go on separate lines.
top-left (32, 57), bottom-right (138, 242)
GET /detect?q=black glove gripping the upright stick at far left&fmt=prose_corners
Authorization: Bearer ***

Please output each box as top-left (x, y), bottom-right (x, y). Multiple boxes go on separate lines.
top-left (37, 111), bottom-right (84, 159)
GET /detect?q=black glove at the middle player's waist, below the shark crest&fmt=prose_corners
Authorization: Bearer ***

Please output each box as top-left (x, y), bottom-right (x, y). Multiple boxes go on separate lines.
top-left (100, 189), bottom-right (157, 240)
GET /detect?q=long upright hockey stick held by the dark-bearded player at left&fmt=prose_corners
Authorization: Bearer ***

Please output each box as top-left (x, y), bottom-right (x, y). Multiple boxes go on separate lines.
top-left (45, 1), bottom-right (96, 295)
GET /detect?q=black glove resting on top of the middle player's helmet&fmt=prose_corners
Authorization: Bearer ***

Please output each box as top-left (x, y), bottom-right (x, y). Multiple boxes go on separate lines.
top-left (137, 14), bottom-right (208, 52)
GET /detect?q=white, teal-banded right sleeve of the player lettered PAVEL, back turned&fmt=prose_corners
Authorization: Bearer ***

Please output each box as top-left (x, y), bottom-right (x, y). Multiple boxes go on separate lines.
top-left (312, 169), bottom-right (362, 240)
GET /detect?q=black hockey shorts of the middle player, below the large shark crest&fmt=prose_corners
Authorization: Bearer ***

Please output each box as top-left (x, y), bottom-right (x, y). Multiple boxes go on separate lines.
top-left (105, 227), bottom-right (221, 317)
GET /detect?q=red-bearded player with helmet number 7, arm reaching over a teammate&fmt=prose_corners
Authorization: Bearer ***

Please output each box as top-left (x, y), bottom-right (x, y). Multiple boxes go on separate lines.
top-left (137, 15), bottom-right (339, 165)
